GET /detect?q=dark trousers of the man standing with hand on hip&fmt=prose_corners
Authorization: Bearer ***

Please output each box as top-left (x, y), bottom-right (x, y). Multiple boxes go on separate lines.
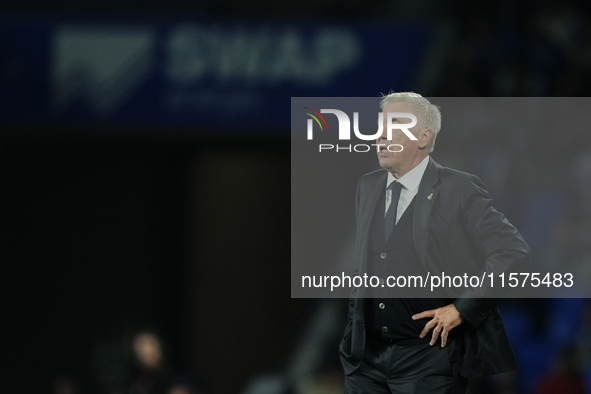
top-left (345, 337), bottom-right (468, 394)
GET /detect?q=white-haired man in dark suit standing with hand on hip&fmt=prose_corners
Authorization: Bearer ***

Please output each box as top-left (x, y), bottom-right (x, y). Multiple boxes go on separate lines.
top-left (340, 93), bottom-right (530, 394)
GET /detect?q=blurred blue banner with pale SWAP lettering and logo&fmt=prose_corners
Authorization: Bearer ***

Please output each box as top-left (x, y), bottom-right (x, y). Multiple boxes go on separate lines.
top-left (0, 20), bottom-right (432, 129)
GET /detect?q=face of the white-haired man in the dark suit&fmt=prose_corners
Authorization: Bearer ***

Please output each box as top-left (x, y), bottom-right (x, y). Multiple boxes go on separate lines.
top-left (377, 103), bottom-right (426, 176)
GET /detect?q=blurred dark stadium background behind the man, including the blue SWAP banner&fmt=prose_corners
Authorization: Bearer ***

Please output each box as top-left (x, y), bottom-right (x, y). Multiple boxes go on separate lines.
top-left (0, 0), bottom-right (591, 394)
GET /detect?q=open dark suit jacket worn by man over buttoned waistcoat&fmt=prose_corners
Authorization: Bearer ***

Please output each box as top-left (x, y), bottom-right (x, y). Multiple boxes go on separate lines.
top-left (340, 158), bottom-right (530, 377)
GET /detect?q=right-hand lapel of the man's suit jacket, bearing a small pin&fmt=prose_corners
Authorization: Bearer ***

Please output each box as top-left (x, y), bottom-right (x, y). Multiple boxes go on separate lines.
top-left (413, 156), bottom-right (439, 267)
